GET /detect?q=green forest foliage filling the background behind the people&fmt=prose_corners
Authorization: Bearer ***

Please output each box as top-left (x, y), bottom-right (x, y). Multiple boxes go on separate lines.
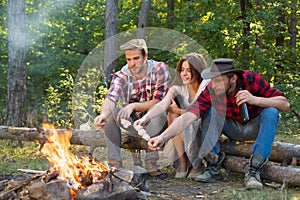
top-left (0, 0), bottom-right (300, 133)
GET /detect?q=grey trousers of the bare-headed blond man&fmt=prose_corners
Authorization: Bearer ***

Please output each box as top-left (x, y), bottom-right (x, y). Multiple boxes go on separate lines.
top-left (104, 108), bottom-right (167, 161)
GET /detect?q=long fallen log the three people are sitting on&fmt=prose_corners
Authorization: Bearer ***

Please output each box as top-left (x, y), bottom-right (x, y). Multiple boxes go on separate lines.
top-left (0, 126), bottom-right (300, 166)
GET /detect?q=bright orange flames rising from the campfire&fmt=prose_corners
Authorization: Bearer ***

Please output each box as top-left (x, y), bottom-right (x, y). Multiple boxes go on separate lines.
top-left (41, 124), bottom-right (108, 195)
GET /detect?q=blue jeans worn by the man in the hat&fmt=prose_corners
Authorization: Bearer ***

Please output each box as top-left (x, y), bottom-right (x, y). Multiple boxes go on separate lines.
top-left (201, 107), bottom-right (278, 158)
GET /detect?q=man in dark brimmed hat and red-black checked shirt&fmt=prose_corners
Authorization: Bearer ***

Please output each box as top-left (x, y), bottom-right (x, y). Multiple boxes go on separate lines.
top-left (148, 58), bottom-right (290, 189)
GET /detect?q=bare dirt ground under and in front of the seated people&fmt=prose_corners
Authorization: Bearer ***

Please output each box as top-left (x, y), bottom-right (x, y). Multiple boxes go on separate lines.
top-left (94, 146), bottom-right (300, 200)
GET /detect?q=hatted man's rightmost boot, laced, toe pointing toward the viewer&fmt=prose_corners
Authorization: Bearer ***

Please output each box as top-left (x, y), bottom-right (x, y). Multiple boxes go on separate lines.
top-left (245, 154), bottom-right (268, 189)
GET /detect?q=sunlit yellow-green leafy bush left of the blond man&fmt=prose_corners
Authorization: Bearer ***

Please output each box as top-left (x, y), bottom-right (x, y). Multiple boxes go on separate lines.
top-left (42, 68), bottom-right (108, 128)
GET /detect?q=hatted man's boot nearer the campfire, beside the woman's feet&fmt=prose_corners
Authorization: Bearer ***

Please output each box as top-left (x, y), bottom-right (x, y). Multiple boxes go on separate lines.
top-left (195, 152), bottom-right (225, 183)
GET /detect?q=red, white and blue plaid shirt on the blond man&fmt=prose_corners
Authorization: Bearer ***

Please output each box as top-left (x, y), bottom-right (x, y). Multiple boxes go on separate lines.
top-left (106, 60), bottom-right (170, 106)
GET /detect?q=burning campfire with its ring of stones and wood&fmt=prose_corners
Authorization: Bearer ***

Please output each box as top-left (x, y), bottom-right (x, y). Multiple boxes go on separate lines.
top-left (0, 124), bottom-right (149, 200)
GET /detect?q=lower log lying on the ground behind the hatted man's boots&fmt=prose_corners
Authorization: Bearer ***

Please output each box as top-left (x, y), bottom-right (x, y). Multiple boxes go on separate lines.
top-left (223, 156), bottom-right (300, 186)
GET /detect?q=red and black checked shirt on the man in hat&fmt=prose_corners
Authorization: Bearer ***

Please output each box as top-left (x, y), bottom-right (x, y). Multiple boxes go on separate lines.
top-left (189, 70), bottom-right (284, 123)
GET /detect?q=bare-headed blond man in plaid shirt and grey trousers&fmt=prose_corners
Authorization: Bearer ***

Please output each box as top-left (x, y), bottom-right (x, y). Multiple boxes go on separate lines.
top-left (94, 39), bottom-right (170, 177)
